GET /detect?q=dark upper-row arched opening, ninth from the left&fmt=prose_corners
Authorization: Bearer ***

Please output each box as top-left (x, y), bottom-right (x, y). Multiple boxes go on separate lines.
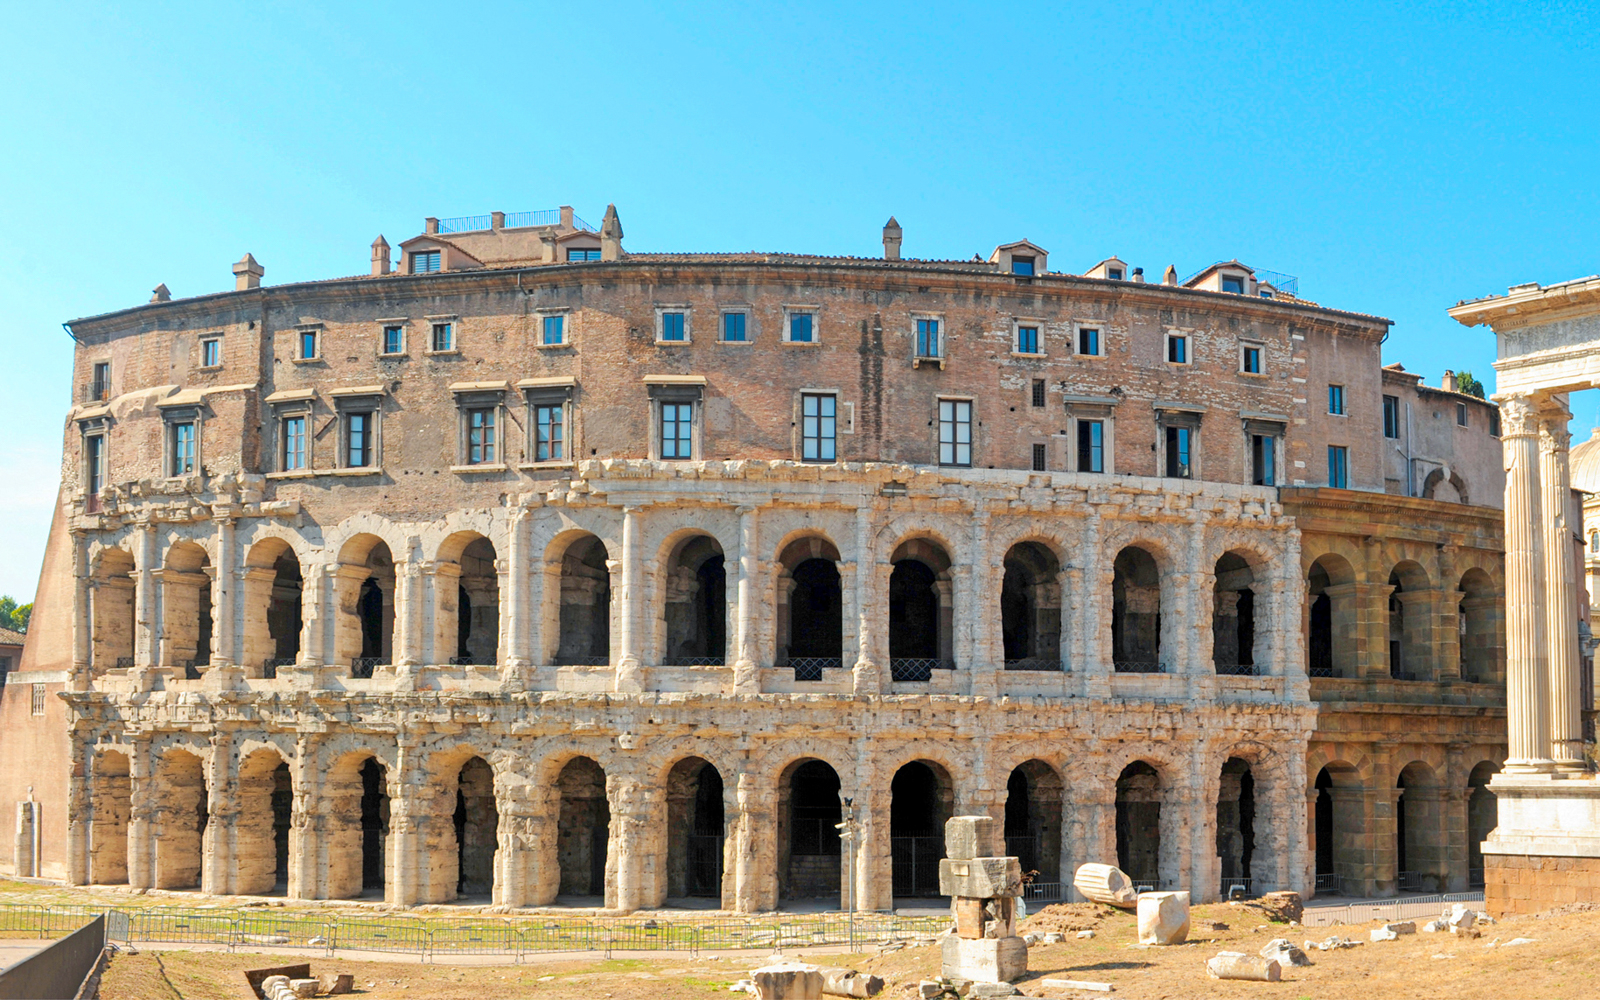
top-left (890, 538), bottom-right (955, 680)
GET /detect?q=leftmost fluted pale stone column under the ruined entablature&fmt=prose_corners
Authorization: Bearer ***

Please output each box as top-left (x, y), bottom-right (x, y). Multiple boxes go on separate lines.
top-left (1498, 395), bottom-right (1555, 774)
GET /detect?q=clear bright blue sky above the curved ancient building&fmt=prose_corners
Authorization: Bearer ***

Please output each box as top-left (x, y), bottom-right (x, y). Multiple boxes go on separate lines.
top-left (0, 0), bottom-right (1600, 602)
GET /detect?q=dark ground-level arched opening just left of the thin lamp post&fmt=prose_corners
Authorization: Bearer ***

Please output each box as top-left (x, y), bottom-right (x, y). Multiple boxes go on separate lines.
top-left (778, 760), bottom-right (843, 899)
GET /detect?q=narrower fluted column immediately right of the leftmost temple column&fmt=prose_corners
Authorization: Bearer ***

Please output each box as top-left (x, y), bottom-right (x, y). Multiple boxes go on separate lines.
top-left (1539, 398), bottom-right (1589, 771)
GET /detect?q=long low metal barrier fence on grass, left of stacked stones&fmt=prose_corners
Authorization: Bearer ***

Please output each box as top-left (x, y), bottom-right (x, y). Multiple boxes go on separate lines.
top-left (0, 904), bottom-right (950, 962)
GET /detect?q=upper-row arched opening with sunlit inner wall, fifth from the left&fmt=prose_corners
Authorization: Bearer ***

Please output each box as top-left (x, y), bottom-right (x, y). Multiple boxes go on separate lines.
top-left (434, 531), bottom-right (499, 666)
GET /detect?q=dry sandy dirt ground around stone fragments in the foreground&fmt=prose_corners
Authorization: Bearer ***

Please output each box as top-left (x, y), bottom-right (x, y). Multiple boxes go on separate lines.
top-left (101, 904), bottom-right (1600, 1000)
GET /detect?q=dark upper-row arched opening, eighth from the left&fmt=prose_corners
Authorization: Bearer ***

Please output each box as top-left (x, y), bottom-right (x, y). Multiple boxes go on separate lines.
top-left (776, 534), bottom-right (845, 680)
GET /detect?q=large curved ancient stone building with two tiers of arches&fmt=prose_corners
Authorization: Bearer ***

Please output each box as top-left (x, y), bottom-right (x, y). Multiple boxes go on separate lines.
top-left (0, 210), bottom-right (1504, 910)
